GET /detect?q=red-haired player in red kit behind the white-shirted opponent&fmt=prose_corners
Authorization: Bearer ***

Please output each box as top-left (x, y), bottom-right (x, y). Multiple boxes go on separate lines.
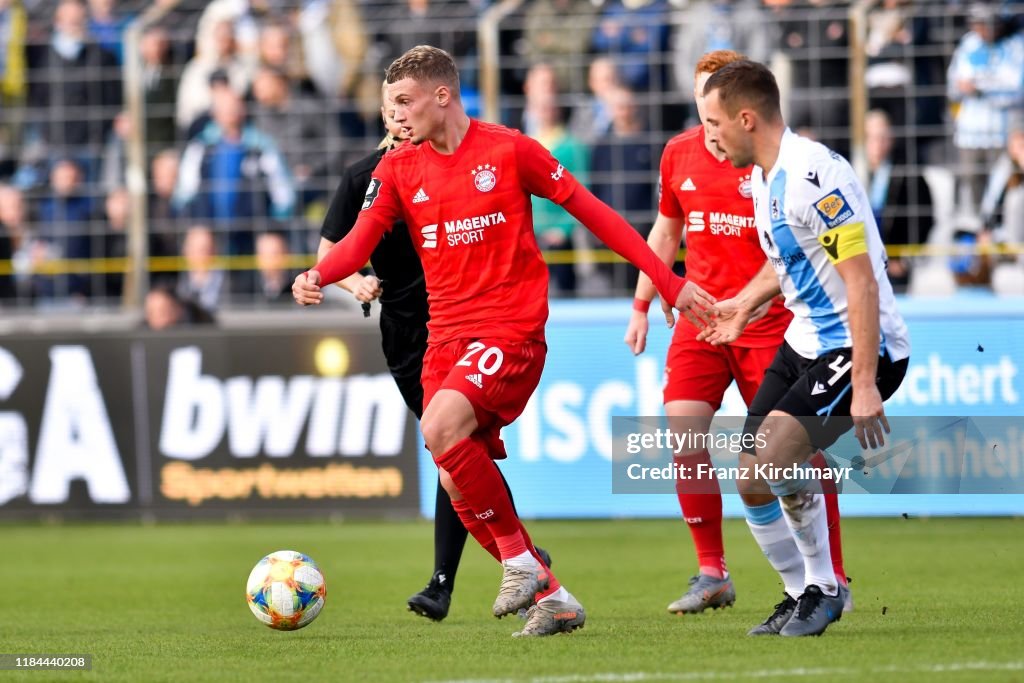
top-left (626, 50), bottom-right (849, 622)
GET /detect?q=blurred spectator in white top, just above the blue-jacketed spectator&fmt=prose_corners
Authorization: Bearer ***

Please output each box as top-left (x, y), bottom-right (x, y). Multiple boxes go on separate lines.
top-left (175, 19), bottom-right (255, 131)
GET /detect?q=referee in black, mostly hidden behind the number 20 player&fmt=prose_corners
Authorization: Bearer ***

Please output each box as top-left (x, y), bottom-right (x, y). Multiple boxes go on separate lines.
top-left (316, 84), bottom-right (551, 622)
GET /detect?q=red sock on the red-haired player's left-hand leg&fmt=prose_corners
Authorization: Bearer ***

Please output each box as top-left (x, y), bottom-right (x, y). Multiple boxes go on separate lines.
top-left (675, 451), bottom-right (726, 578)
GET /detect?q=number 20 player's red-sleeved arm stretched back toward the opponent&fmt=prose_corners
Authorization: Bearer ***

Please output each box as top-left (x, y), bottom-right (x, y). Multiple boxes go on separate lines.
top-left (562, 185), bottom-right (715, 317)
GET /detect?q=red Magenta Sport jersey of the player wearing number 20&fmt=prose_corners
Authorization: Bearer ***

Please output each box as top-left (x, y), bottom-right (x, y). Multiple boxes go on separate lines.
top-left (337, 119), bottom-right (579, 344)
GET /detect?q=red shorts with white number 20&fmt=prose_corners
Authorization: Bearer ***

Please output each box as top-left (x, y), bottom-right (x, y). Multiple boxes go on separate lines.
top-left (422, 339), bottom-right (548, 431)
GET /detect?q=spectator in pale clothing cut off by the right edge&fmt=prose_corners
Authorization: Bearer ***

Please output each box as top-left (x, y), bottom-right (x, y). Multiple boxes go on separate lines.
top-left (981, 111), bottom-right (1024, 252)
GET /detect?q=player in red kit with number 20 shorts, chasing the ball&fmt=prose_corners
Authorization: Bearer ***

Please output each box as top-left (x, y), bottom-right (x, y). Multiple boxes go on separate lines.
top-left (292, 45), bottom-right (715, 636)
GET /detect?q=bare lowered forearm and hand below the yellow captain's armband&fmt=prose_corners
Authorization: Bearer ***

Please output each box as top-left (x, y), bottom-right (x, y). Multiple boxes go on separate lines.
top-left (836, 253), bottom-right (889, 449)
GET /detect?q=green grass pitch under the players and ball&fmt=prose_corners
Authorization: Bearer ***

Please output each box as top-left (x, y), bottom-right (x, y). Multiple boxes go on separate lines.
top-left (0, 517), bottom-right (1024, 683)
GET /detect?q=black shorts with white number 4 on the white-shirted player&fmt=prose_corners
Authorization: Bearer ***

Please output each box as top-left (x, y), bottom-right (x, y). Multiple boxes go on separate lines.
top-left (743, 343), bottom-right (909, 449)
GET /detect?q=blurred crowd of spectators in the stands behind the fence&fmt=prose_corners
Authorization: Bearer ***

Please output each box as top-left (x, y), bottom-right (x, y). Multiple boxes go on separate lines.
top-left (0, 0), bottom-right (1024, 319)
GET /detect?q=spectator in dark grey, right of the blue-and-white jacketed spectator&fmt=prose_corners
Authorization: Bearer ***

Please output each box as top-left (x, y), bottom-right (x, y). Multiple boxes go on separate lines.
top-left (253, 67), bottom-right (341, 202)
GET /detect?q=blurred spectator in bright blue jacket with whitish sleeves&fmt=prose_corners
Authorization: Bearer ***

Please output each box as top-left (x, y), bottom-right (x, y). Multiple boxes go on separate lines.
top-left (173, 90), bottom-right (296, 256)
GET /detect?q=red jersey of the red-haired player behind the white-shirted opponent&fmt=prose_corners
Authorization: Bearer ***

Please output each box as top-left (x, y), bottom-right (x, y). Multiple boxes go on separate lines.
top-left (658, 126), bottom-right (793, 347)
